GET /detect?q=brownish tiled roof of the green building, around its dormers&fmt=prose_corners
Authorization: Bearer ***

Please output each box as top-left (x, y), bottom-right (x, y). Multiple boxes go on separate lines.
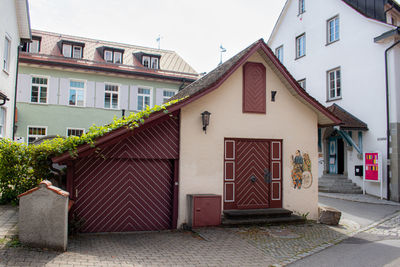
top-left (26, 30), bottom-right (197, 75)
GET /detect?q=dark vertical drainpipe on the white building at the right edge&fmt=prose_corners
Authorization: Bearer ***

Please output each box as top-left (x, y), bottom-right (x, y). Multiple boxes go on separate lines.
top-left (385, 40), bottom-right (400, 200)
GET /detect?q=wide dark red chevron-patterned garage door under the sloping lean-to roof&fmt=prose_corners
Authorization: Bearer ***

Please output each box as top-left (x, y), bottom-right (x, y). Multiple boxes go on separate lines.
top-left (74, 158), bottom-right (172, 232)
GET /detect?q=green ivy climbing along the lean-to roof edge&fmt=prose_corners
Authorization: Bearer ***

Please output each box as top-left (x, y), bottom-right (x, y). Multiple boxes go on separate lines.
top-left (0, 98), bottom-right (183, 204)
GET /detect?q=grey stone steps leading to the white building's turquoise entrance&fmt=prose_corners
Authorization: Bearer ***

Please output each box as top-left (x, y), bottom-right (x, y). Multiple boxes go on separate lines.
top-left (318, 174), bottom-right (362, 194)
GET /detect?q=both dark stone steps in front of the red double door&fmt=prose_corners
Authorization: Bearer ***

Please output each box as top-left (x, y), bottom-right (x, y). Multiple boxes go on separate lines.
top-left (222, 208), bottom-right (305, 226)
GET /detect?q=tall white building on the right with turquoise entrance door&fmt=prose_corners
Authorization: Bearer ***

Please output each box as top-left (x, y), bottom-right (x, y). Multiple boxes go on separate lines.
top-left (268, 0), bottom-right (400, 201)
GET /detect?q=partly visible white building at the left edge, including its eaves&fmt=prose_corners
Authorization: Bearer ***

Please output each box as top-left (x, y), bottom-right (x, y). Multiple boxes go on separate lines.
top-left (0, 0), bottom-right (31, 138)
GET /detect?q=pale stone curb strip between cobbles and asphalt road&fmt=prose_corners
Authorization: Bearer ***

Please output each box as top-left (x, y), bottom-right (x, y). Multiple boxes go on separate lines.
top-left (272, 211), bottom-right (400, 267)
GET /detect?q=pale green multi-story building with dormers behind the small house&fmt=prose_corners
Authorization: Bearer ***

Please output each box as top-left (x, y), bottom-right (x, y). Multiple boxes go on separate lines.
top-left (16, 30), bottom-right (198, 143)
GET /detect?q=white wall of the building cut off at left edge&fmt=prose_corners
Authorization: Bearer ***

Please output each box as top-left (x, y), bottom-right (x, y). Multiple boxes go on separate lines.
top-left (0, 0), bottom-right (20, 138)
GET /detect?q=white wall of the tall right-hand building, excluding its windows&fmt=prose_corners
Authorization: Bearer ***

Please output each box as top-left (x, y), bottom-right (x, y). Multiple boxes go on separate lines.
top-left (268, 0), bottom-right (392, 198)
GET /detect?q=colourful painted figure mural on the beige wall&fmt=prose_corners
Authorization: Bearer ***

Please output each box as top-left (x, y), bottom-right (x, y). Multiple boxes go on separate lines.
top-left (292, 150), bottom-right (312, 189)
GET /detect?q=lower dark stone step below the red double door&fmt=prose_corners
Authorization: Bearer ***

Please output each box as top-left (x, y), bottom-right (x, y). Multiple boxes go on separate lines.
top-left (222, 215), bottom-right (306, 226)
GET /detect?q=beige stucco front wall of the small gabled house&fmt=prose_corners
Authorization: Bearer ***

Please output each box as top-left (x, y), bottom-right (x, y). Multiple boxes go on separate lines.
top-left (178, 50), bottom-right (318, 227)
